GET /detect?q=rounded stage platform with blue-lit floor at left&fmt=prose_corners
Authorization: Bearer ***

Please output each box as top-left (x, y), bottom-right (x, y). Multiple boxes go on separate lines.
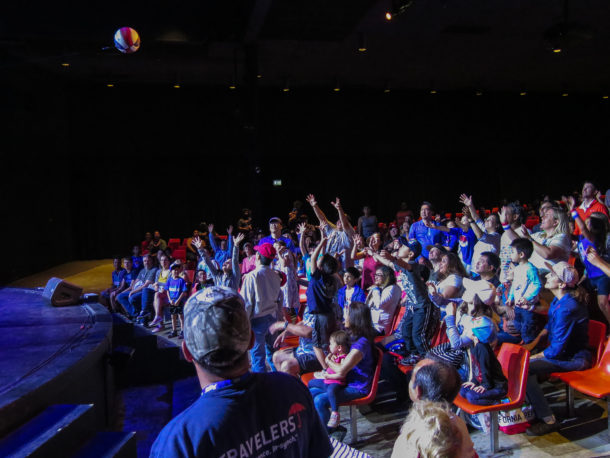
top-left (0, 288), bottom-right (113, 437)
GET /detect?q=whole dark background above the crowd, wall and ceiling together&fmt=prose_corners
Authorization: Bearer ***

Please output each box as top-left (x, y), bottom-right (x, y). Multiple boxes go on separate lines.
top-left (0, 0), bottom-right (610, 284)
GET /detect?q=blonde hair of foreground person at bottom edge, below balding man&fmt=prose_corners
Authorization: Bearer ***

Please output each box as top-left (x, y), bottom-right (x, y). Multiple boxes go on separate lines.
top-left (392, 401), bottom-right (462, 458)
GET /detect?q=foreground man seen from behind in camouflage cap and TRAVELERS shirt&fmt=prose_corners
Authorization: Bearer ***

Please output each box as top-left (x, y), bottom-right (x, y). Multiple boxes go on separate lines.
top-left (150, 286), bottom-right (332, 458)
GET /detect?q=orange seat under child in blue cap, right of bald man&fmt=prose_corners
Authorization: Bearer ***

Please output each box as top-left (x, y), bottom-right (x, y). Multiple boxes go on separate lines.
top-left (453, 343), bottom-right (530, 453)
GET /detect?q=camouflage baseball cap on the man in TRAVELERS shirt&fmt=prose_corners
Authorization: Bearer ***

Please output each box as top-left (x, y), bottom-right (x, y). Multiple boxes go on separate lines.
top-left (184, 286), bottom-right (250, 368)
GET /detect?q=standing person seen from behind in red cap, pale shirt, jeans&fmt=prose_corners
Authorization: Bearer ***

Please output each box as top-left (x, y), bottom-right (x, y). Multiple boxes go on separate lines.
top-left (241, 243), bottom-right (286, 372)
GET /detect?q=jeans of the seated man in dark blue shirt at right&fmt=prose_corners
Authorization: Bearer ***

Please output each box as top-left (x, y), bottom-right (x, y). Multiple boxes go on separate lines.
top-left (527, 350), bottom-right (591, 419)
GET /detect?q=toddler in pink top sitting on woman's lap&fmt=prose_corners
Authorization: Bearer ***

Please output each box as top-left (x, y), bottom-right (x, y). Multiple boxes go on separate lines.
top-left (309, 331), bottom-right (351, 428)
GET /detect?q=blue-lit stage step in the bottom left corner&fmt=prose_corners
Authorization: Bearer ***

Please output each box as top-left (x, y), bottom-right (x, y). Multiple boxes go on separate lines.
top-left (0, 404), bottom-right (95, 458)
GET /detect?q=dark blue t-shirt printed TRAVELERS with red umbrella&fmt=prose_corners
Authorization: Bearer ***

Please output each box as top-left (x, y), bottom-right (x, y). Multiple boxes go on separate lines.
top-left (150, 372), bottom-right (333, 458)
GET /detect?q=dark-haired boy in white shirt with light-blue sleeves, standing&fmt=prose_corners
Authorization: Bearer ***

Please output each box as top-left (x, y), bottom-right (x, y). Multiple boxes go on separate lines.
top-left (506, 238), bottom-right (542, 344)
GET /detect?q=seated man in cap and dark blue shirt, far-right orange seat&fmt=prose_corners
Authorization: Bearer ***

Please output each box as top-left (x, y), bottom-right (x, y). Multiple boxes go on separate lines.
top-left (524, 261), bottom-right (591, 436)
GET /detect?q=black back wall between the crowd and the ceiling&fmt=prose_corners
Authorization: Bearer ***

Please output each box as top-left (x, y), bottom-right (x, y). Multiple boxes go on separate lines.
top-left (2, 74), bottom-right (610, 281)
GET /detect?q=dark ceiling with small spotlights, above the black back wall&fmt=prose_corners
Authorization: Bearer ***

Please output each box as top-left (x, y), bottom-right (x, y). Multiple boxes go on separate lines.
top-left (0, 0), bottom-right (610, 95)
